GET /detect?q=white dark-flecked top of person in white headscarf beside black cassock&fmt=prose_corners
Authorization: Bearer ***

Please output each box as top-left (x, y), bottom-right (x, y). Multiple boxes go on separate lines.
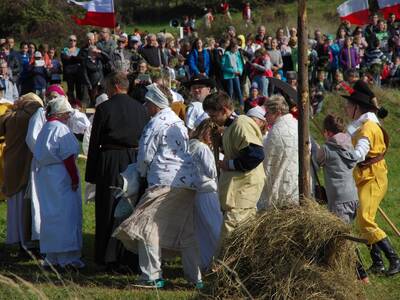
top-left (137, 107), bottom-right (195, 187)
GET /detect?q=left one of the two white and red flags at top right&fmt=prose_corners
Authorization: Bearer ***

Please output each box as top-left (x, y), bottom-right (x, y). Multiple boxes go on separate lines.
top-left (337, 0), bottom-right (370, 25)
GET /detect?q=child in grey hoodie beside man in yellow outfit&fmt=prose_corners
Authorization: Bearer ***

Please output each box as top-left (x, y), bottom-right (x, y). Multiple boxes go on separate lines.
top-left (317, 115), bottom-right (368, 282)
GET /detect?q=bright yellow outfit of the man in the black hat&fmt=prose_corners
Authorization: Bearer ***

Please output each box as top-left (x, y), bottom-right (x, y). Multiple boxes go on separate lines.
top-left (353, 120), bottom-right (388, 245)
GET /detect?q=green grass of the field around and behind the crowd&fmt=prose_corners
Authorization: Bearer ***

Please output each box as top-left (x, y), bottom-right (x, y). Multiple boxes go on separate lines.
top-left (0, 0), bottom-right (400, 300)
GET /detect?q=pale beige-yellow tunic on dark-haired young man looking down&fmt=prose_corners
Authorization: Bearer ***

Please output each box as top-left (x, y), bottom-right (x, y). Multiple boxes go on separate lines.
top-left (219, 116), bottom-right (265, 240)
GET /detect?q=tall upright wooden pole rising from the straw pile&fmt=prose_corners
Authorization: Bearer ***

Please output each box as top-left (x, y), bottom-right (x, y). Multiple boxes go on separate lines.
top-left (298, 0), bottom-right (311, 201)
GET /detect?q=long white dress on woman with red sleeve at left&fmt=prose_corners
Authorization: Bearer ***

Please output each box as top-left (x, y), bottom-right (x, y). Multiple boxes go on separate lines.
top-left (33, 121), bottom-right (83, 267)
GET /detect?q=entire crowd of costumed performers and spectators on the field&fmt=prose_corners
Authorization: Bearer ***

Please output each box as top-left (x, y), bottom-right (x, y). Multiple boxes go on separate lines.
top-left (0, 9), bottom-right (400, 288)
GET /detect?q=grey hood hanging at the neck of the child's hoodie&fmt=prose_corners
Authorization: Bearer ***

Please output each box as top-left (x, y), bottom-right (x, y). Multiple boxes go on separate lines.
top-left (326, 133), bottom-right (357, 168)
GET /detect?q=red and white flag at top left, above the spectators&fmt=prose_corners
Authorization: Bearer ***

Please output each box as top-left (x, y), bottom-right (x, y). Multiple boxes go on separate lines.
top-left (68, 0), bottom-right (115, 28)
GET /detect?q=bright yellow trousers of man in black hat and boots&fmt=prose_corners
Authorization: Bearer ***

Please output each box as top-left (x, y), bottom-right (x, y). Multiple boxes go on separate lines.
top-left (356, 176), bottom-right (388, 245)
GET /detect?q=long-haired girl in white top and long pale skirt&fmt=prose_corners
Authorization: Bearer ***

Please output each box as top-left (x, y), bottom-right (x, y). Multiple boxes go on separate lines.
top-left (189, 119), bottom-right (222, 271)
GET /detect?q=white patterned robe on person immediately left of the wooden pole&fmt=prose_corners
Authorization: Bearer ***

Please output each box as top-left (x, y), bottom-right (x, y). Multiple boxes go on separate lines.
top-left (257, 114), bottom-right (299, 208)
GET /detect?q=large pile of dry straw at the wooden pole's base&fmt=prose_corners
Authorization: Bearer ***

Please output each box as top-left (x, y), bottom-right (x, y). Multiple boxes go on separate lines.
top-left (210, 200), bottom-right (364, 299)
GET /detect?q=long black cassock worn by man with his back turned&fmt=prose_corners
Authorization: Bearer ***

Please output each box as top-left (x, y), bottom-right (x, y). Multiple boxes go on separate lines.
top-left (85, 94), bottom-right (149, 264)
